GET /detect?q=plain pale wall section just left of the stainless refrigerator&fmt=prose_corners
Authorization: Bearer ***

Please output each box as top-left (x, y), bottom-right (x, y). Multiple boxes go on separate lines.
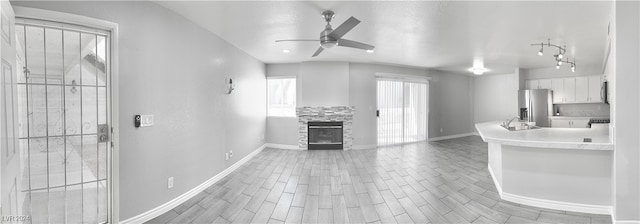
top-left (473, 74), bottom-right (518, 123)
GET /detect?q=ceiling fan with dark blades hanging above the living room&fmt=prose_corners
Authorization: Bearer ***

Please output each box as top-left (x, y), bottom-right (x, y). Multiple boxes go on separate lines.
top-left (276, 10), bottom-right (375, 57)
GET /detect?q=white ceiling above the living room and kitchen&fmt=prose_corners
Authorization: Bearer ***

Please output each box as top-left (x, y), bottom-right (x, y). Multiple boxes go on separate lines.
top-left (157, 1), bottom-right (611, 74)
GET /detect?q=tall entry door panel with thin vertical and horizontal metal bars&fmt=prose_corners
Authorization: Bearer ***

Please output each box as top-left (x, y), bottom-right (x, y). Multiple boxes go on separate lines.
top-left (16, 19), bottom-right (111, 223)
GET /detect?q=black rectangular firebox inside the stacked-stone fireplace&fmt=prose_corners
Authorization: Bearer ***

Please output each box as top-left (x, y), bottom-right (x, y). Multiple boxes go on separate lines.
top-left (308, 121), bottom-right (344, 149)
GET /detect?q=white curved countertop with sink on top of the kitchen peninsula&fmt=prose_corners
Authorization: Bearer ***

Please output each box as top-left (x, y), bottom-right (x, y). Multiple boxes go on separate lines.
top-left (476, 121), bottom-right (613, 150)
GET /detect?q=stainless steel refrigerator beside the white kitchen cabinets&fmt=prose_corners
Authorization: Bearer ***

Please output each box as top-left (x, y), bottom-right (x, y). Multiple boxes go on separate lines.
top-left (518, 89), bottom-right (553, 127)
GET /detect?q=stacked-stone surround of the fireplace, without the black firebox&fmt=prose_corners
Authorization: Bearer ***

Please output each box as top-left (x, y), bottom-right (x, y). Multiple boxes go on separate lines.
top-left (296, 106), bottom-right (355, 150)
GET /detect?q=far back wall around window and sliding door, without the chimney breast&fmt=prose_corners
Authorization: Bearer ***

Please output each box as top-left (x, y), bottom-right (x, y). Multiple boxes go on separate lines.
top-left (267, 63), bottom-right (473, 146)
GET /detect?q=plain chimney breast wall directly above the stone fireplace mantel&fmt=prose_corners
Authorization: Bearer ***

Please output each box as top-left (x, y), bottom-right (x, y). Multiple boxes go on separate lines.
top-left (296, 62), bottom-right (349, 107)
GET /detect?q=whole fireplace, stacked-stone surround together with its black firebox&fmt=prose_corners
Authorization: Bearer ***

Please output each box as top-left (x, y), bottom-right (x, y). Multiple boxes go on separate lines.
top-left (296, 106), bottom-right (355, 150)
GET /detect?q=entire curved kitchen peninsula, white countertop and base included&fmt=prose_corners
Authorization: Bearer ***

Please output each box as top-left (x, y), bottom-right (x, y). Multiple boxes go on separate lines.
top-left (476, 121), bottom-right (613, 214)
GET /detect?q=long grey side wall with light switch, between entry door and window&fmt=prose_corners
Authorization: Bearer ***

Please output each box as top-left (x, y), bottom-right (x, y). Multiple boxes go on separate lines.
top-left (12, 2), bottom-right (266, 220)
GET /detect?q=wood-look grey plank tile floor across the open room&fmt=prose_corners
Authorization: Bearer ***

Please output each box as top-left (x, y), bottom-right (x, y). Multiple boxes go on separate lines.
top-left (150, 136), bottom-right (611, 223)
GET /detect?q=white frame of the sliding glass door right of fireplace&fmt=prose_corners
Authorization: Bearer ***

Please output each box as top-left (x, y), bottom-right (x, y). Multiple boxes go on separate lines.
top-left (375, 72), bottom-right (431, 146)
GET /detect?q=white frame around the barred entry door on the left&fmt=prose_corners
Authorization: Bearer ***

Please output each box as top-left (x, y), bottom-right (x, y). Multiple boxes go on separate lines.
top-left (13, 6), bottom-right (120, 223)
